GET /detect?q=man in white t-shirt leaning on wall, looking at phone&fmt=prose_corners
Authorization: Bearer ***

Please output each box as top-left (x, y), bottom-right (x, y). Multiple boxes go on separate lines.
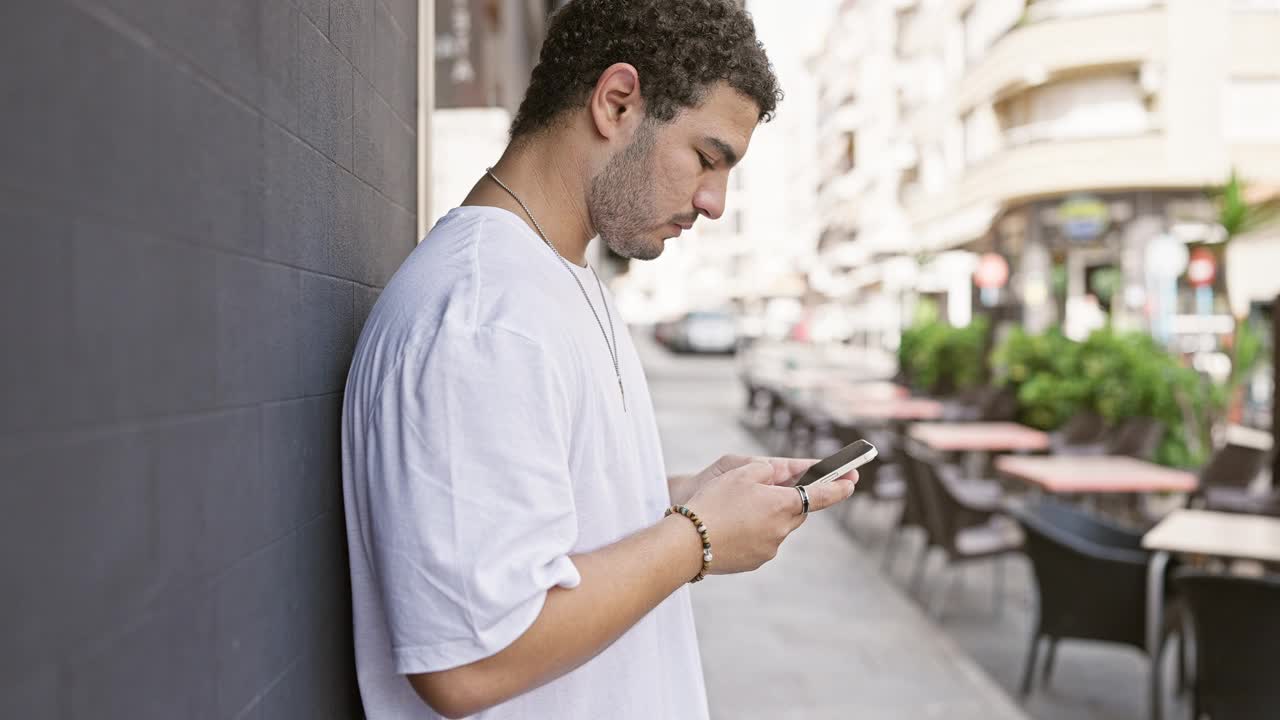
top-left (343, 0), bottom-right (855, 720)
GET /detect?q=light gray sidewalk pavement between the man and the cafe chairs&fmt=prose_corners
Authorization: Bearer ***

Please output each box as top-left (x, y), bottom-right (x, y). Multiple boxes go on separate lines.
top-left (636, 333), bottom-right (1027, 720)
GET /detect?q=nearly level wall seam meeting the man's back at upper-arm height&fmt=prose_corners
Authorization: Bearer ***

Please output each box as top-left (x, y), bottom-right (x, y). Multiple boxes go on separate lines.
top-left (0, 391), bottom-right (346, 459)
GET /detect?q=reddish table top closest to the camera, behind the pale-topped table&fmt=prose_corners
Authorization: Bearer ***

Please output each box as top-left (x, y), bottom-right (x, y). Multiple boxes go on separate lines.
top-left (996, 455), bottom-right (1197, 493)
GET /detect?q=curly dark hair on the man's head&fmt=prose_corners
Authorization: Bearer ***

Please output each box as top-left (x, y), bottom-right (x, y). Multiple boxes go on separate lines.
top-left (511, 0), bottom-right (782, 140)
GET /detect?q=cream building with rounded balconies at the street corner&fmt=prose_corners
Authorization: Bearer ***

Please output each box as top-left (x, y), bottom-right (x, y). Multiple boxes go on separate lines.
top-left (823, 0), bottom-right (1280, 345)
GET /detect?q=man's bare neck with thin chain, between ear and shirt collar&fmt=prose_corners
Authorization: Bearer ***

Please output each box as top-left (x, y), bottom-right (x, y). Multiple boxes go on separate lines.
top-left (462, 136), bottom-right (595, 266)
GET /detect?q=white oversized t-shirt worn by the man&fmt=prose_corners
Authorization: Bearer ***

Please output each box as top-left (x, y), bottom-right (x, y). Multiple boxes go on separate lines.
top-left (342, 208), bottom-right (708, 720)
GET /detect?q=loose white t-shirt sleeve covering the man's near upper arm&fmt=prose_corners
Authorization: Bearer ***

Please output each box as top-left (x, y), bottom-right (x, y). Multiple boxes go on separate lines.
top-left (366, 327), bottom-right (580, 674)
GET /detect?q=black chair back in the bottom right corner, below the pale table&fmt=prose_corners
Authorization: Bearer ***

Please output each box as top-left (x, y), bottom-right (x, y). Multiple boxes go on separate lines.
top-left (1174, 570), bottom-right (1280, 720)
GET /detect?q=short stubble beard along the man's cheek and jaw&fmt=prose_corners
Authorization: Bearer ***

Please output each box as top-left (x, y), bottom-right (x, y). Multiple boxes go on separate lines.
top-left (586, 120), bottom-right (663, 260)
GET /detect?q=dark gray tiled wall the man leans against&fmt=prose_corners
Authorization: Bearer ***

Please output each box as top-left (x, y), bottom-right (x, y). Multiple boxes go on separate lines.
top-left (0, 0), bottom-right (417, 720)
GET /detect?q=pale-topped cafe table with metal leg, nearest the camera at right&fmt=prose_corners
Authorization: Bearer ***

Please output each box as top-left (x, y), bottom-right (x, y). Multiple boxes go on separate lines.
top-left (1142, 510), bottom-right (1280, 717)
